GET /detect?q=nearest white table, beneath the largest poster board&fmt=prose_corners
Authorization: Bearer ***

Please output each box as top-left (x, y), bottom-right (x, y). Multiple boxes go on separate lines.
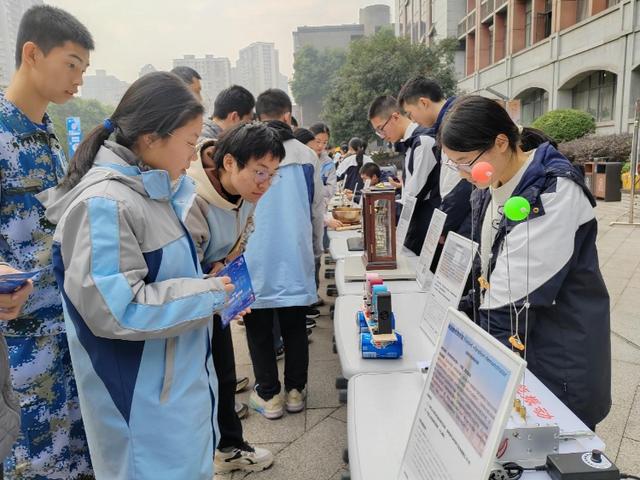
top-left (347, 369), bottom-right (604, 480)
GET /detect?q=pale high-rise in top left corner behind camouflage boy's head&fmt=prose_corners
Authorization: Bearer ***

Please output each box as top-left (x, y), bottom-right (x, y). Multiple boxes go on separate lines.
top-left (0, 0), bottom-right (43, 87)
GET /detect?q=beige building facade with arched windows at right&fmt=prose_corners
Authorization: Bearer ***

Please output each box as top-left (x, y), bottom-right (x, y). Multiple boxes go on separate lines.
top-left (458, 0), bottom-right (640, 133)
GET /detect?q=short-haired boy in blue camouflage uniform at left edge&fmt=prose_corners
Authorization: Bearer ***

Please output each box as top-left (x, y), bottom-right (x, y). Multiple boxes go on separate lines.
top-left (0, 5), bottom-right (93, 479)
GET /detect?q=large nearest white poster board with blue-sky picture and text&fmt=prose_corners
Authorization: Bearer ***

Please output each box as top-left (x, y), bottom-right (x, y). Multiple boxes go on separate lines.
top-left (398, 308), bottom-right (526, 480)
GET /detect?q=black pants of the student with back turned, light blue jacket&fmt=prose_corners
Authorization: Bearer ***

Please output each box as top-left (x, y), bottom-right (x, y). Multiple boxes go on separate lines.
top-left (244, 307), bottom-right (309, 400)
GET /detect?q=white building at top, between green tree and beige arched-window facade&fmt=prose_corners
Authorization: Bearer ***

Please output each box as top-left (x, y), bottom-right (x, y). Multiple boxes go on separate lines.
top-left (396, 0), bottom-right (467, 78)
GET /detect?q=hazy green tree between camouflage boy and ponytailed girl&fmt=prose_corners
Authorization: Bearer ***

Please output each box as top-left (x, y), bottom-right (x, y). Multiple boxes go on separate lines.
top-left (48, 98), bottom-right (114, 156)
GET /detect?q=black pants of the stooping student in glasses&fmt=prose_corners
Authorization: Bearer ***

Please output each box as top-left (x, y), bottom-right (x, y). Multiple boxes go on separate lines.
top-left (211, 315), bottom-right (243, 449)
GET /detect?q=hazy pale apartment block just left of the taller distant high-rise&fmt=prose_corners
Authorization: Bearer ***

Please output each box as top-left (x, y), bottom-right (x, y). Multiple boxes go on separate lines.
top-left (173, 55), bottom-right (231, 112)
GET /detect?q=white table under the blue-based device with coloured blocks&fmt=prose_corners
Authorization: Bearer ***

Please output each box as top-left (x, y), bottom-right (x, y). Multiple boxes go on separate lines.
top-left (333, 292), bottom-right (434, 378)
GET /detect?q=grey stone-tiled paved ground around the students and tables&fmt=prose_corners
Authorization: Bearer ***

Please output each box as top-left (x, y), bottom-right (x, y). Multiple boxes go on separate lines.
top-left (215, 193), bottom-right (640, 480)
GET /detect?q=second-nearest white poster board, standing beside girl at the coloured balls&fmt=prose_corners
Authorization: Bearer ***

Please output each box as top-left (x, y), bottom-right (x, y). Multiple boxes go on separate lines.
top-left (420, 232), bottom-right (478, 346)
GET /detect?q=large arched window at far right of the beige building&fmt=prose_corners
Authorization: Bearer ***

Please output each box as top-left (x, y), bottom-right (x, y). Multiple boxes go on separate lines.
top-left (572, 71), bottom-right (617, 122)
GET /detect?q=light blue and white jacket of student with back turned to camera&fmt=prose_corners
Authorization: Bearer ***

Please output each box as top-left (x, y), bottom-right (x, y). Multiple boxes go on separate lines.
top-left (245, 139), bottom-right (324, 308)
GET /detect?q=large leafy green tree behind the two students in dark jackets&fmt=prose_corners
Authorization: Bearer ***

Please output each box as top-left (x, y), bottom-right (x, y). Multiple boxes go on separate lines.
top-left (323, 29), bottom-right (457, 142)
